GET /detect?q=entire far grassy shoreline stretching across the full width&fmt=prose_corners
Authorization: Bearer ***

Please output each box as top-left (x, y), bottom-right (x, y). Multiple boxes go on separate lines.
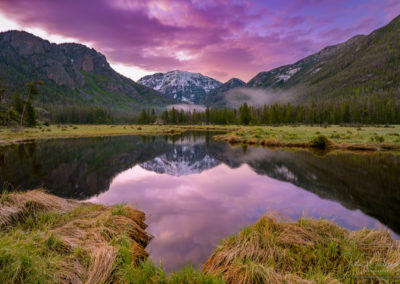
top-left (0, 125), bottom-right (400, 152)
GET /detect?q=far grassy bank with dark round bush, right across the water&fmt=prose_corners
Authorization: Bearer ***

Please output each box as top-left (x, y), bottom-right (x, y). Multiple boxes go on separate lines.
top-left (214, 125), bottom-right (400, 151)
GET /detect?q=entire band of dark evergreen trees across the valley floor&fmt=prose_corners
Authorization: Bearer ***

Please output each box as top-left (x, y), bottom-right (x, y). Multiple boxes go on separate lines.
top-left (0, 77), bottom-right (400, 126)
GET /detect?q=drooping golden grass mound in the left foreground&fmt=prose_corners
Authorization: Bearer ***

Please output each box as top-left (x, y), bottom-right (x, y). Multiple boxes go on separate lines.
top-left (0, 190), bottom-right (151, 283)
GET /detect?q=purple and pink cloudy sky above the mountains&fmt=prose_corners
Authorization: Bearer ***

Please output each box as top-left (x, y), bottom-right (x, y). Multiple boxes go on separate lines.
top-left (0, 0), bottom-right (400, 82)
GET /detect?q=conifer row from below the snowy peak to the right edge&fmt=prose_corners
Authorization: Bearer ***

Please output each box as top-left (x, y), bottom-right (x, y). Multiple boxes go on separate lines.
top-left (137, 96), bottom-right (400, 125)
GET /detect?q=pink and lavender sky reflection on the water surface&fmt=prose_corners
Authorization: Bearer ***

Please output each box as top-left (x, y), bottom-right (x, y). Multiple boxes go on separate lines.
top-left (88, 164), bottom-right (383, 270)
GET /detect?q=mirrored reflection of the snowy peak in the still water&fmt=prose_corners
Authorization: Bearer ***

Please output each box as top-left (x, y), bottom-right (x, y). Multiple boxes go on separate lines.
top-left (140, 145), bottom-right (221, 176)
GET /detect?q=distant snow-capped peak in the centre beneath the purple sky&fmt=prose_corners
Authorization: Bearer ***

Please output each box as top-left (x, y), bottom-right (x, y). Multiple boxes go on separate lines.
top-left (138, 70), bottom-right (222, 104)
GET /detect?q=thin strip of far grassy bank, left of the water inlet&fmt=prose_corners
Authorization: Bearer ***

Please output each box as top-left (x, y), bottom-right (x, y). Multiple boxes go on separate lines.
top-left (0, 124), bottom-right (238, 144)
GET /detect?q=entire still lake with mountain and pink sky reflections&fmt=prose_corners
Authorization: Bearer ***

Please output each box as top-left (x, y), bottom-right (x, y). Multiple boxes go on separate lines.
top-left (0, 133), bottom-right (400, 270)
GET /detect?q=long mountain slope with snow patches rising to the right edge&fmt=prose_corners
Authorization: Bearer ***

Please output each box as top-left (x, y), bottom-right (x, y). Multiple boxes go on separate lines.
top-left (247, 16), bottom-right (400, 102)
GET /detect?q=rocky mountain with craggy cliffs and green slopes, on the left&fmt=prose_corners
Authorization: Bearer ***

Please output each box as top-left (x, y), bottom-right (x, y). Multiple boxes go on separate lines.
top-left (0, 30), bottom-right (174, 109)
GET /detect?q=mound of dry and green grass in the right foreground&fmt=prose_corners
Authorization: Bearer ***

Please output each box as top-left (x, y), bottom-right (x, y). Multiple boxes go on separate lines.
top-left (203, 216), bottom-right (400, 283)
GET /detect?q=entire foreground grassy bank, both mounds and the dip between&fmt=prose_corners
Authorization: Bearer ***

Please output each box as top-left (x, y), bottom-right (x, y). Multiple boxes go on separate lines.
top-left (0, 190), bottom-right (400, 284)
